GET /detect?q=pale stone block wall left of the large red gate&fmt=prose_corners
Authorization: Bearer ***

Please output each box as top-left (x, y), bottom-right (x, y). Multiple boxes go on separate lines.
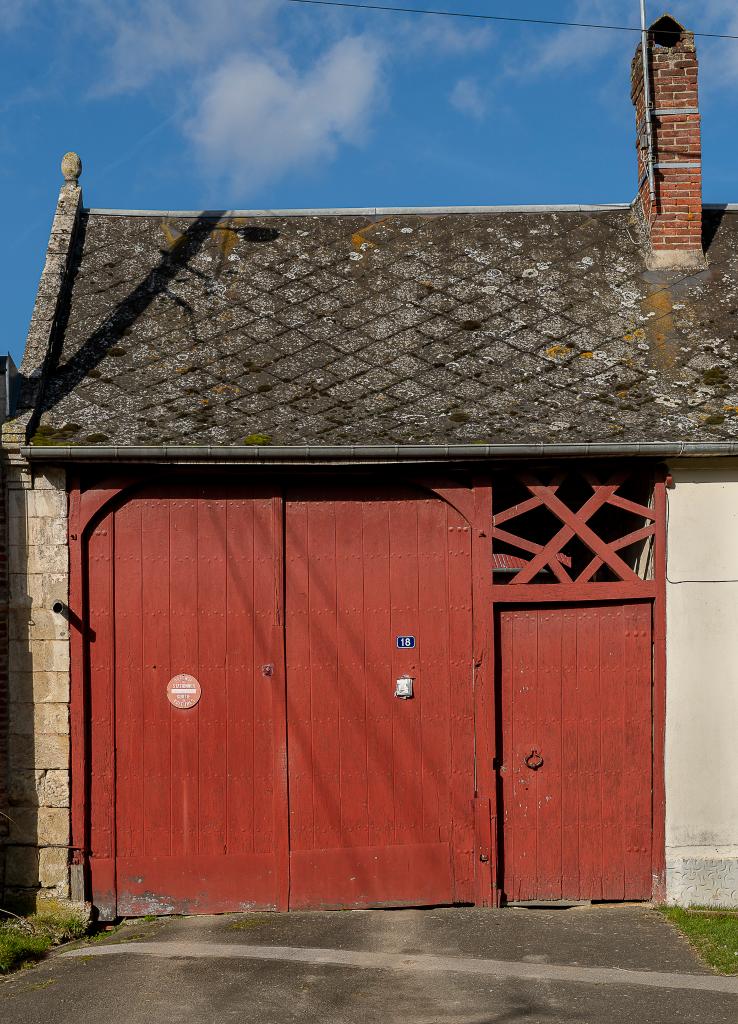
top-left (5, 463), bottom-right (70, 901)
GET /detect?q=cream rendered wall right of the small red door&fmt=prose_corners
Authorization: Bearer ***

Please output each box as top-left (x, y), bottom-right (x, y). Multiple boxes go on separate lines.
top-left (665, 459), bottom-right (738, 906)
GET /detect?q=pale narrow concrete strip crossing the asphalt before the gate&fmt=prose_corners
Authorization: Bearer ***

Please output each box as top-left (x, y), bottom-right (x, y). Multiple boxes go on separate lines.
top-left (60, 942), bottom-right (738, 995)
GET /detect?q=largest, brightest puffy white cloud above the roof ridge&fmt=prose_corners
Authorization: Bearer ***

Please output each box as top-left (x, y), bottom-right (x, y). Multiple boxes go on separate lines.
top-left (185, 36), bottom-right (382, 190)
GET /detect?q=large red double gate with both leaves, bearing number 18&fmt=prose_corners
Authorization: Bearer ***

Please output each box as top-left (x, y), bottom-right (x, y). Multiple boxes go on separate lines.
top-left (87, 485), bottom-right (476, 914)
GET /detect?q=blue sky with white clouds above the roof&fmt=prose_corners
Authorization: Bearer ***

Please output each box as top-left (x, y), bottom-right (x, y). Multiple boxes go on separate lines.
top-left (0, 0), bottom-right (738, 362)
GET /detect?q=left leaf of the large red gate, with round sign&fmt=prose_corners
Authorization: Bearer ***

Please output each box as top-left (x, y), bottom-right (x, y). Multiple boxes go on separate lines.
top-left (90, 486), bottom-right (287, 915)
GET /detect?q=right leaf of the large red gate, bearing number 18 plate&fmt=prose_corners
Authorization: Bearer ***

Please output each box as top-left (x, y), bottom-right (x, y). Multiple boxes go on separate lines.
top-left (285, 484), bottom-right (474, 908)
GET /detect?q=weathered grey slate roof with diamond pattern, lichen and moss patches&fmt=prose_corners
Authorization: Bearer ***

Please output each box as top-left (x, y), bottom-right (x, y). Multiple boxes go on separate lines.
top-left (25, 209), bottom-right (738, 444)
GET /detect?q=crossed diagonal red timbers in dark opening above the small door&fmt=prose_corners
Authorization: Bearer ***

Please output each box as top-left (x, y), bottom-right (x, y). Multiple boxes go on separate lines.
top-left (492, 470), bottom-right (656, 587)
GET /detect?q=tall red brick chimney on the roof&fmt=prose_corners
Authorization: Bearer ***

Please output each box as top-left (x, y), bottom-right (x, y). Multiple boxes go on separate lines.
top-left (631, 14), bottom-right (704, 268)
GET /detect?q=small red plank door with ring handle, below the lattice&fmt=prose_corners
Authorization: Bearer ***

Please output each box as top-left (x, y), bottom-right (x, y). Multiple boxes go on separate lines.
top-left (497, 602), bottom-right (652, 901)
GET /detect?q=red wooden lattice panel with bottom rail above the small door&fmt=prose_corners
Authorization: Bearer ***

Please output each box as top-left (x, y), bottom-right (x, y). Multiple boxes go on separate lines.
top-left (492, 467), bottom-right (663, 601)
